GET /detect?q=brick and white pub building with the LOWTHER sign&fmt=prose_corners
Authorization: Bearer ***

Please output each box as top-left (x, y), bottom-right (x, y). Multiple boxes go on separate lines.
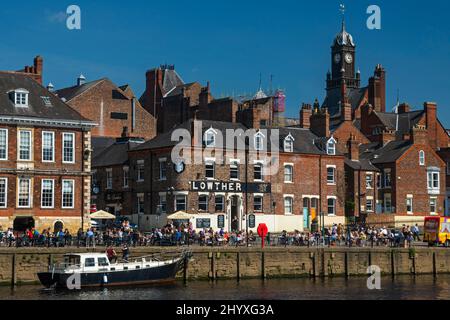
top-left (111, 120), bottom-right (345, 232)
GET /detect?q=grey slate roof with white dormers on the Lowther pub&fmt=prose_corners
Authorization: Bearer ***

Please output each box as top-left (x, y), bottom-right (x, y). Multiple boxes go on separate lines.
top-left (133, 120), bottom-right (326, 155)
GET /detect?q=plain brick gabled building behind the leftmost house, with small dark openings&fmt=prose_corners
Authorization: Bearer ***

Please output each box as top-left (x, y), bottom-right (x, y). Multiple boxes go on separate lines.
top-left (56, 76), bottom-right (156, 139)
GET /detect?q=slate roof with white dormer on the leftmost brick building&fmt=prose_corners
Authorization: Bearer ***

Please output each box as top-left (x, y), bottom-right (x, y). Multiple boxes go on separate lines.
top-left (0, 72), bottom-right (94, 125)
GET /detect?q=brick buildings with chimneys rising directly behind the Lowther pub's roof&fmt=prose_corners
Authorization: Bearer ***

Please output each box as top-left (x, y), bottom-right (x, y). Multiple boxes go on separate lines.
top-left (140, 66), bottom-right (284, 133)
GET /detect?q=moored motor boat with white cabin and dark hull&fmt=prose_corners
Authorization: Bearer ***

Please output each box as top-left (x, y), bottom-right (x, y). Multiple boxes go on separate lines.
top-left (38, 251), bottom-right (191, 289)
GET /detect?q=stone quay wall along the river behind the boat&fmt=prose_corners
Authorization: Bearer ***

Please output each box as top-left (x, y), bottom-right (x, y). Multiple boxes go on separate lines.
top-left (0, 247), bottom-right (450, 285)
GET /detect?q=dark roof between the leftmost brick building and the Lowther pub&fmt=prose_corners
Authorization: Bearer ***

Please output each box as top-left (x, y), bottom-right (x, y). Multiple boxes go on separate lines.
top-left (92, 139), bottom-right (145, 168)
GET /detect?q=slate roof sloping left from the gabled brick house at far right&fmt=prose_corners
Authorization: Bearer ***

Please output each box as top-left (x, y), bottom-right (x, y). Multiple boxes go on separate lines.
top-left (360, 140), bottom-right (412, 164)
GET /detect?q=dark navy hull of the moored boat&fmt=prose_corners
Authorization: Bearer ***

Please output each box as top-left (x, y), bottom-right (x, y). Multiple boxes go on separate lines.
top-left (38, 262), bottom-right (180, 289)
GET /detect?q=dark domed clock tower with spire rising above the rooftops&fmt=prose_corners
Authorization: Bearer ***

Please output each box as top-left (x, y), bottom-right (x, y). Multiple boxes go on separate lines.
top-left (327, 12), bottom-right (360, 91)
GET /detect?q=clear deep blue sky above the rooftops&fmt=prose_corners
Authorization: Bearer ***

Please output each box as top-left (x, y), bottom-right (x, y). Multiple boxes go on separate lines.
top-left (0, 0), bottom-right (450, 127)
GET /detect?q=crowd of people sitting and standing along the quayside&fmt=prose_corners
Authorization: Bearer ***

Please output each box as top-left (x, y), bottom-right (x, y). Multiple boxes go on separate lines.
top-left (0, 222), bottom-right (426, 247)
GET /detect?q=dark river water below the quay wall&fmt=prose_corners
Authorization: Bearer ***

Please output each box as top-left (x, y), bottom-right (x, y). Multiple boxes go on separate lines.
top-left (0, 276), bottom-right (450, 300)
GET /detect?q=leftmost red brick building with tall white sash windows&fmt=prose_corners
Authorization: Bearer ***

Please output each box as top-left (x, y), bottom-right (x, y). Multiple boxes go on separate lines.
top-left (0, 71), bottom-right (95, 232)
